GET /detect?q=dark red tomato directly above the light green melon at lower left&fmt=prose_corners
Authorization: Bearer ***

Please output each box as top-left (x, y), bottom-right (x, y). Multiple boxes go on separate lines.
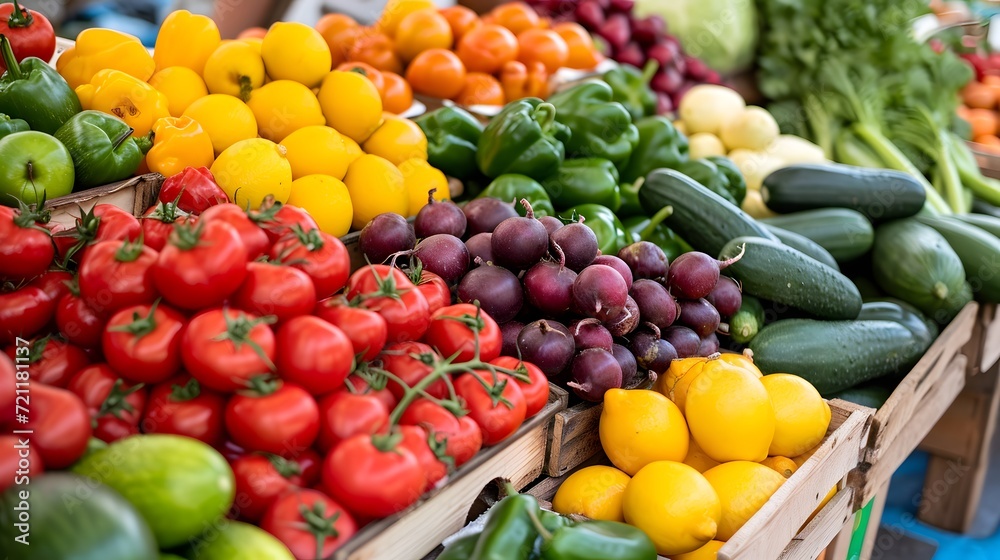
top-left (140, 375), bottom-right (226, 447)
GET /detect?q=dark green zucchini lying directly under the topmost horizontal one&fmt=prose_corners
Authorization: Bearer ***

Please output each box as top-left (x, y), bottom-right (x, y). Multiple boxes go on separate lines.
top-left (761, 208), bottom-right (875, 263)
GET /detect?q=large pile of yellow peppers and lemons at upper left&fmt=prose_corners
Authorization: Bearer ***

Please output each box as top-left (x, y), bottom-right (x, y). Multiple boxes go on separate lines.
top-left (56, 10), bottom-right (448, 236)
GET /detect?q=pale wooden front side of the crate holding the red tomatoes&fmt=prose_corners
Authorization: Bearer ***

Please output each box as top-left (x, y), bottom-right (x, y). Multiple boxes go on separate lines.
top-left (333, 387), bottom-right (567, 560)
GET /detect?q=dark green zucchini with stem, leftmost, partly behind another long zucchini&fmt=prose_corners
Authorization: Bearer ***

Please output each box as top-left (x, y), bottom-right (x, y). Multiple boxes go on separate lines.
top-left (639, 169), bottom-right (777, 255)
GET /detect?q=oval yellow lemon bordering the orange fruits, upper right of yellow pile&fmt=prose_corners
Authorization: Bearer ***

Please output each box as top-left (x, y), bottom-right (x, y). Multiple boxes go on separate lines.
top-left (318, 70), bottom-right (382, 142)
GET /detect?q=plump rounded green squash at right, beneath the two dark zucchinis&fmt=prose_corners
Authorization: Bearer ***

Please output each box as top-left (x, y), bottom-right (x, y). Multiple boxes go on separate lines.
top-left (872, 220), bottom-right (972, 325)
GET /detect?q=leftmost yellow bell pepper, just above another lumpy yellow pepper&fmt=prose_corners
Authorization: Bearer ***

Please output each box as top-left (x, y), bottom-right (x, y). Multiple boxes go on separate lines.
top-left (56, 28), bottom-right (156, 89)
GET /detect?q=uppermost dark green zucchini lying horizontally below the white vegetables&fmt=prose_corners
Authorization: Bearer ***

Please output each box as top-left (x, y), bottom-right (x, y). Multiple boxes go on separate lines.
top-left (760, 163), bottom-right (927, 221)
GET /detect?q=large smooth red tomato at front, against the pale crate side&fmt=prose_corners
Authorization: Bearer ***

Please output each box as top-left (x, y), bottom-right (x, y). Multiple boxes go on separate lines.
top-left (323, 435), bottom-right (427, 517)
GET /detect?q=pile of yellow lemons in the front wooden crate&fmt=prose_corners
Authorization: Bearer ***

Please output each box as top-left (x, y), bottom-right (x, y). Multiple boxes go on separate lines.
top-left (552, 354), bottom-right (836, 560)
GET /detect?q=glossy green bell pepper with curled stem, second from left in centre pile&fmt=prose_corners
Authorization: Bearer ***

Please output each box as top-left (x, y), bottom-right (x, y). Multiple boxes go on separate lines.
top-left (476, 97), bottom-right (571, 180)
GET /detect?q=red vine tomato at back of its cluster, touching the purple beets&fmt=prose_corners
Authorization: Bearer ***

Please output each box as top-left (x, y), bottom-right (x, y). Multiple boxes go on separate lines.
top-left (424, 303), bottom-right (503, 362)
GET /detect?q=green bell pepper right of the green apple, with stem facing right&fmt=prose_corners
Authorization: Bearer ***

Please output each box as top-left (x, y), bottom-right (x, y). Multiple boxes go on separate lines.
top-left (53, 111), bottom-right (150, 189)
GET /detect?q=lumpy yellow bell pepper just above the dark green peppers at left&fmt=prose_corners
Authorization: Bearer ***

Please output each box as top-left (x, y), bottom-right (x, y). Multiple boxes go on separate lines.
top-left (76, 70), bottom-right (170, 137)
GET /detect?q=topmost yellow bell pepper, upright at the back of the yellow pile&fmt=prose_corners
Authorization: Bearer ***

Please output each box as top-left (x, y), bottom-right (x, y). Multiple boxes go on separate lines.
top-left (153, 10), bottom-right (222, 74)
